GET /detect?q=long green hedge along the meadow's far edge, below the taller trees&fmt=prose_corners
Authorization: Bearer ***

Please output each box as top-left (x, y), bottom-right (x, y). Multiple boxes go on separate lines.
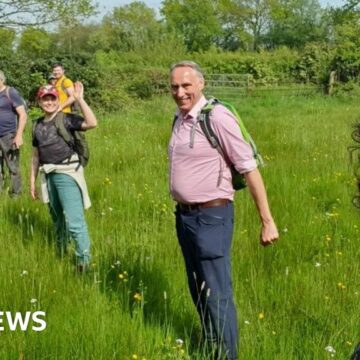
top-left (0, 44), bottom-right (360, 112)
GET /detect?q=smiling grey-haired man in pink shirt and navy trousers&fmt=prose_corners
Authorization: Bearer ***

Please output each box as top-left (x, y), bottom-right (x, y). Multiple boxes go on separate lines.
top-left (169, 61), bottom-right (278, 360)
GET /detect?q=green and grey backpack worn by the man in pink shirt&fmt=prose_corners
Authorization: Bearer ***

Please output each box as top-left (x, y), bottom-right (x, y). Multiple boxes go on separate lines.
top-left (198, 98), bottom-right (264, 190)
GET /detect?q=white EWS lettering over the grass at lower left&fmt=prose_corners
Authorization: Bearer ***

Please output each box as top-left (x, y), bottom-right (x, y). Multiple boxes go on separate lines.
top-left (0, 311), bottom-right (46, 332)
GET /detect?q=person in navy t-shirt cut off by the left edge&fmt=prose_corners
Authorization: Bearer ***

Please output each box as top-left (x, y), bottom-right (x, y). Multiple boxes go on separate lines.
top-left (0, 70), bottom-right (27, 196)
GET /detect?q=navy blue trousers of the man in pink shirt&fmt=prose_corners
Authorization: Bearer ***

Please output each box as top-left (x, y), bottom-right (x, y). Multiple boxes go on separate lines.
top-left (176, 203), bottom-right (238, 360)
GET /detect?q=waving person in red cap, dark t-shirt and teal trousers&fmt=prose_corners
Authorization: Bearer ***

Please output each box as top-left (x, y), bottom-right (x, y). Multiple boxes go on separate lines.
top-left (30, 82), bottom-right (97, 272)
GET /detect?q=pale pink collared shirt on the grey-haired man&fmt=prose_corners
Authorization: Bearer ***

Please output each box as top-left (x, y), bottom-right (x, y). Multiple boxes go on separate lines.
top-left (169, 97), bottom-right (257, 204)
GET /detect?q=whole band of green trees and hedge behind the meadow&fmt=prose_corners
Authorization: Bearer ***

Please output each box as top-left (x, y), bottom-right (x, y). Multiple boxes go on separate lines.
top-left (0, 0), bottom-right (360, 111)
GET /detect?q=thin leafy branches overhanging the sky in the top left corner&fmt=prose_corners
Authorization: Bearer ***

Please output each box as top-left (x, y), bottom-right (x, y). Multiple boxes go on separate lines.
top-left (0, 0), bottom-right (95, 27)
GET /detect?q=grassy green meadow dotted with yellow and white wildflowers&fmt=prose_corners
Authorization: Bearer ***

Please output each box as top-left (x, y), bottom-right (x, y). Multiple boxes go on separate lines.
top-left (0, 96), bottom-right (360, 360)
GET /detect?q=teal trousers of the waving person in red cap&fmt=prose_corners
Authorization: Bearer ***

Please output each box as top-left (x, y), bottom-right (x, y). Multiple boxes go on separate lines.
top-left (46, 173), bottom-right (90, 265)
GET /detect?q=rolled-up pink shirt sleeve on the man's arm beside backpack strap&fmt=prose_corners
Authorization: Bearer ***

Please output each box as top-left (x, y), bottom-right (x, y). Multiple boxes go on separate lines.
top-left (210, 105), bottom-right (257, 174)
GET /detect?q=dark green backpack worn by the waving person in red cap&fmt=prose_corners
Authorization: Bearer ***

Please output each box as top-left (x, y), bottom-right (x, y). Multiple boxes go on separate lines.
top-left (33, 112), bottom-right (90, 170)
